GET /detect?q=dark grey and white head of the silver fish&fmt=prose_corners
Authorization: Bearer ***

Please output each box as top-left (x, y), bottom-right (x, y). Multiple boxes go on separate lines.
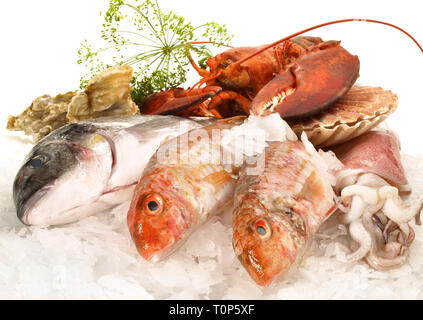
top-left (13, 126), bottom-right (112, 225)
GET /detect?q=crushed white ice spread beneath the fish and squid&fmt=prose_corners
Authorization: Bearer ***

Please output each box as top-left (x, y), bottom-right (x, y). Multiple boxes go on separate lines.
top-left (0, 124), bottom-right (423, 299)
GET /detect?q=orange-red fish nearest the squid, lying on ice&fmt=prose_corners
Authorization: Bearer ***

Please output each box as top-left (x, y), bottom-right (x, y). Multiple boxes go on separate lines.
top-left (232, 141), bottom-right (334, 286)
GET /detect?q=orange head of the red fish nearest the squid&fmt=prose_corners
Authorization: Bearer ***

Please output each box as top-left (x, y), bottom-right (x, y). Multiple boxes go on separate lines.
top-left (233, 201), bottom-right (297, 286)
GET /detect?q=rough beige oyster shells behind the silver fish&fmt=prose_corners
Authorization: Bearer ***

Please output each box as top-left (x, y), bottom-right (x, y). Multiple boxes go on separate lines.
top-left (6, 66), bottom-right (139, 142)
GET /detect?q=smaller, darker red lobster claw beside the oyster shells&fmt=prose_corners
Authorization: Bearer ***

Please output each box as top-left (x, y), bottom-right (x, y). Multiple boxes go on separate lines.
top-left (141, 86), bottom-right (222, 115)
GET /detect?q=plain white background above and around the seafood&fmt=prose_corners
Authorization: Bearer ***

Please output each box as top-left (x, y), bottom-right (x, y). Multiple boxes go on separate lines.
top-left (0, 0), bottom-right (423, 154)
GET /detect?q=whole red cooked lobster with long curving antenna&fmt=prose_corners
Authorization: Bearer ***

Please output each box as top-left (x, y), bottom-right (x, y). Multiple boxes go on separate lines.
top-left (140, 19), bottom-right (423, 120)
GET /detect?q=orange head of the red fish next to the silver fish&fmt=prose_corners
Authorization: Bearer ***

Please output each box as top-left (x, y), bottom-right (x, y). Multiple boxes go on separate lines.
top-left (127, 168), bottom-right (196, 262)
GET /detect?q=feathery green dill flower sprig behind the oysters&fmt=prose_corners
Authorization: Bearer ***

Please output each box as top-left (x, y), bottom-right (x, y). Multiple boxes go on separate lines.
top-left (78, 0), bottom-right (233, 105)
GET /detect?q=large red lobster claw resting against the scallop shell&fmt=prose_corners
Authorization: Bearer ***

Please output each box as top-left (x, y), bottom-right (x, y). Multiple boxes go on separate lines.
top-left (251, 41), bottom-right (360, 119)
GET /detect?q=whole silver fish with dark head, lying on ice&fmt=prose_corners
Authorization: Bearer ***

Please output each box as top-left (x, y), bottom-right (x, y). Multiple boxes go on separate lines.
top-left (13, 115), bottom-right (213, 225)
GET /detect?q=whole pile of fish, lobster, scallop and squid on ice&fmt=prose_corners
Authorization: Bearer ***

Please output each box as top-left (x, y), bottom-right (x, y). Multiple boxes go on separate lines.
top-left (6, 18), bottom-right (423, 286)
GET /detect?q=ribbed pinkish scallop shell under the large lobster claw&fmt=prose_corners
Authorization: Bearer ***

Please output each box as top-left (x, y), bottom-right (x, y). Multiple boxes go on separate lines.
top-left (289, 86), bottom-right (398, 147)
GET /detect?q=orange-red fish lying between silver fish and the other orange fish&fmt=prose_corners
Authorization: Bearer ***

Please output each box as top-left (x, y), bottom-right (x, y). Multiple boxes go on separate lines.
top-left (127, 117), bottom-right (244, 262)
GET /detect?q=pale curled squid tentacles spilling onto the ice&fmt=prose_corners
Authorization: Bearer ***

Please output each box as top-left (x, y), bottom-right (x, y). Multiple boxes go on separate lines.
top-left (341, 175), bottom-right (423, 270)
